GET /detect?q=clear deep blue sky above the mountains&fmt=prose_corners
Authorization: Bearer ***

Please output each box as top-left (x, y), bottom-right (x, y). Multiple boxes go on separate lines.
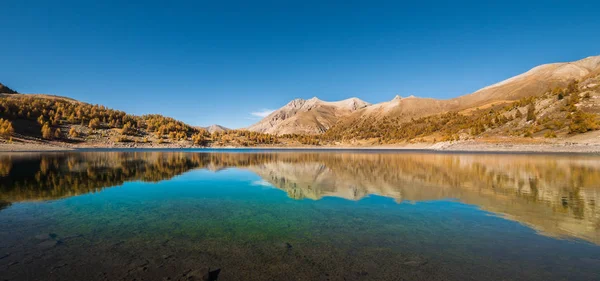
top-left (0, 0), bottom-right (600, 128)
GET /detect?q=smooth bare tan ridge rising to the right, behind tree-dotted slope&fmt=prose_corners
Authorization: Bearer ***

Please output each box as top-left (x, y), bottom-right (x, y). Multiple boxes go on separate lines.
top-left (335, 56), bottom-right (600, 136)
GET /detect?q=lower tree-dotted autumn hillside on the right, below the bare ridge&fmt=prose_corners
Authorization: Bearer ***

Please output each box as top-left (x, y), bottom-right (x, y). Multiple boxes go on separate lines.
top-left (323, 76), bottom-right (600, 144)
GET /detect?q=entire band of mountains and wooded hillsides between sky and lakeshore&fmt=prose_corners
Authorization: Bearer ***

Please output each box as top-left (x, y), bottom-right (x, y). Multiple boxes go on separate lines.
top-left (0, 53), bottom-right (600, 147)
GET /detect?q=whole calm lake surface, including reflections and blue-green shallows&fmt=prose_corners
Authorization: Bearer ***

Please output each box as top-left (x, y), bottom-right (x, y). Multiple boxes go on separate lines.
top-left (0, 150), bottom-right (600, 280)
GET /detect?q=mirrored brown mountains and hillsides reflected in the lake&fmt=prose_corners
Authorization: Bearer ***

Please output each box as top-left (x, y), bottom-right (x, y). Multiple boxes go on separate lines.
top-left (0, 152), bottom-right (600, 244)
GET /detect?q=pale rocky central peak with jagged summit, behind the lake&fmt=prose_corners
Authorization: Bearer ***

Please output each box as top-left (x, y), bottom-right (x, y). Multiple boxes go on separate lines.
top-left (247, 97), bottom-right (370, 135)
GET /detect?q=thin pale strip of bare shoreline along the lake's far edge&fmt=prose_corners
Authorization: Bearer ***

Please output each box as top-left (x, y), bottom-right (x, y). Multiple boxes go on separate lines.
top-left (0, 141), bottom-right (600, 154)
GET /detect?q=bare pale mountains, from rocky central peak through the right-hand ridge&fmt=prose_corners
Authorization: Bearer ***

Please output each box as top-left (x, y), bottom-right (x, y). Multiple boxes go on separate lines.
top-left (247, 56), bottom-right (600, 135)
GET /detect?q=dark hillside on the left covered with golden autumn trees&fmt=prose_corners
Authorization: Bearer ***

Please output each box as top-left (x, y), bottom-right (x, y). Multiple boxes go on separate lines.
top-left (0, 94), bottom-right (318, 147)
